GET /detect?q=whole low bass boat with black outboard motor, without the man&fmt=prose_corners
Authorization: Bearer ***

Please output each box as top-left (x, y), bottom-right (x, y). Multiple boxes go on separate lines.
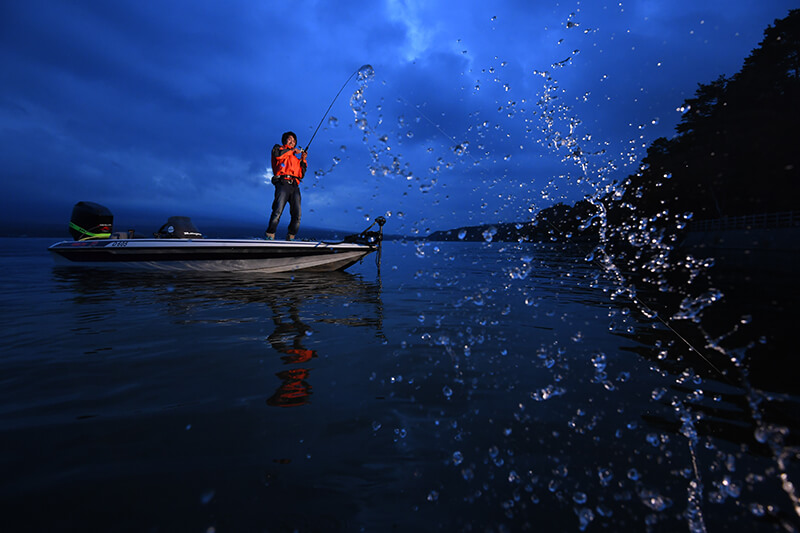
top-left (48, 202), bottom-right (386, 273)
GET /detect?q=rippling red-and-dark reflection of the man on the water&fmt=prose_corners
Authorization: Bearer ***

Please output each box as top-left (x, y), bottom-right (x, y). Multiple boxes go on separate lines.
top-left (267, 305), bottom-right (317, 407)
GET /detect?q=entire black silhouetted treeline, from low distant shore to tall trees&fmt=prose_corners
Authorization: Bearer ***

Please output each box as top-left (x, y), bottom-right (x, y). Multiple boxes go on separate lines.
top-left (429, 9), bottom-right (800, 242)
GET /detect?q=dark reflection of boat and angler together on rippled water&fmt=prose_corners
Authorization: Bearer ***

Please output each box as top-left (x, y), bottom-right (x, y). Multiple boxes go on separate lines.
top-left (53, 268), bottom-right (385, 407)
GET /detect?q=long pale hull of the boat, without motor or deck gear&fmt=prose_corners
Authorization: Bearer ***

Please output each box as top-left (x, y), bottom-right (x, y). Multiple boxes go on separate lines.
top-left (48, 239), bottom-right (377, 272)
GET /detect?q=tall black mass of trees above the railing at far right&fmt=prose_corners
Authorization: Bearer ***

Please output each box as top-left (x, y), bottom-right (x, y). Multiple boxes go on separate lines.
top-left (626, 9), bottom-right (800, 218)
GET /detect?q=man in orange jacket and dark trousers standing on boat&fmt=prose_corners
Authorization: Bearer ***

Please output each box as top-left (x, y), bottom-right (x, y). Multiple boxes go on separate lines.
top-left (267, 131), bottom-right (308, 241)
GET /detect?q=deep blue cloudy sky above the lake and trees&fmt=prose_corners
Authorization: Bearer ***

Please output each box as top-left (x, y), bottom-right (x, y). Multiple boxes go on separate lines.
top-left (0, 0), bottom-right (796, 234)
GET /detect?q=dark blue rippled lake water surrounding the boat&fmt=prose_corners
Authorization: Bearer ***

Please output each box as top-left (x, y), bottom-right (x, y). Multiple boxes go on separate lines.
top-left (0, 239), bottom-right (800, 532)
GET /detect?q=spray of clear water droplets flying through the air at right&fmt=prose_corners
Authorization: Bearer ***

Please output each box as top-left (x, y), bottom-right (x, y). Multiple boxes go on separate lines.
top-left (351, 8), bottom-right (794, 531)
